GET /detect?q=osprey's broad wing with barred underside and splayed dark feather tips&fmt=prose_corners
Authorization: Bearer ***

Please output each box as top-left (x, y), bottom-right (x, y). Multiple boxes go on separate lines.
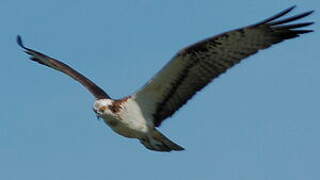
top-left (134, 6), bottom-right (313, 126)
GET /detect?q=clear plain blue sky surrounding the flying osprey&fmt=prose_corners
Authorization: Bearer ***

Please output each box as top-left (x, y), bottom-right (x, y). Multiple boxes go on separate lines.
top-left (0, 0), bottom-right (320, 180)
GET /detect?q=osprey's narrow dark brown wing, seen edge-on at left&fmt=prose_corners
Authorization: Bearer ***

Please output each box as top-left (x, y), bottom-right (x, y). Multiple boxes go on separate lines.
top-left (17, 36), bottom-right (110, 99)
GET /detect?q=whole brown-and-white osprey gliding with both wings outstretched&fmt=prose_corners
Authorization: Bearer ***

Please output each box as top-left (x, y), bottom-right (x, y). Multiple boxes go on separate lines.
top-left (17, 6), bottom-right (313, 151)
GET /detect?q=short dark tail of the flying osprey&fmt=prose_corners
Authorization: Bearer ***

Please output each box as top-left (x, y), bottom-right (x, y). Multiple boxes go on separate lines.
top-left (140, 129), bottom-right (184, 152)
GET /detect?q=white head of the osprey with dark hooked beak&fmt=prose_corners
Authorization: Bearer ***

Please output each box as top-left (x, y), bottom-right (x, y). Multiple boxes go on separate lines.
top-left (93, 99), bottom-right (114, 117)
